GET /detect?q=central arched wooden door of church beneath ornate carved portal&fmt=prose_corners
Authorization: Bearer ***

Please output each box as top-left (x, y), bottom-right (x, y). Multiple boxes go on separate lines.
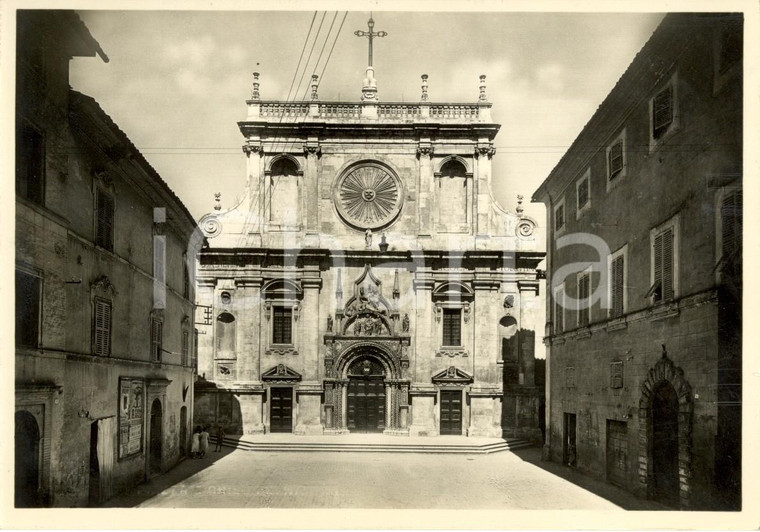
top-left (347, 356), bottom-right (385, 432)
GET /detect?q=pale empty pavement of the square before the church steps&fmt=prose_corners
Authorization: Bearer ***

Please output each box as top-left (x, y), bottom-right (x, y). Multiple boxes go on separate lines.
top-left (107, 448), bottom-right (662, 510)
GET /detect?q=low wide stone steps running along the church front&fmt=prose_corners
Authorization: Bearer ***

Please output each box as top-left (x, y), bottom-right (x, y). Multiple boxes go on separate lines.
top-left (211, 436), bottom-right (533, 454)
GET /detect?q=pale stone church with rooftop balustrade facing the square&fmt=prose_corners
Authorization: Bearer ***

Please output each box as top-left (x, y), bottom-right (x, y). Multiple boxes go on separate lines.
top-left (195, 20), bottom-right (544, 440)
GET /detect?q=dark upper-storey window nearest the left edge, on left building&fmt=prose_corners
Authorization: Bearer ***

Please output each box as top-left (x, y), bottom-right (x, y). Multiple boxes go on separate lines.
top-left (16, 118), bottom-right (45, 205)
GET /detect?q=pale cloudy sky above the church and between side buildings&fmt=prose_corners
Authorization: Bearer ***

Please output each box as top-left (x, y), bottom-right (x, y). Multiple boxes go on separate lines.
top-left (70, 10), bottom-right (663, 226)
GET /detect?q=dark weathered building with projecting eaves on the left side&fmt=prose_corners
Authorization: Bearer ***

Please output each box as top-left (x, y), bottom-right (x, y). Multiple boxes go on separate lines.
top-left (15, 10), bottom-right (200, 507)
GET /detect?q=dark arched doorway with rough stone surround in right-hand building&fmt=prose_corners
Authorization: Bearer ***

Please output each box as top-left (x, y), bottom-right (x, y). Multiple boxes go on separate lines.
top-left (652, 381), bottom-right (680, 505)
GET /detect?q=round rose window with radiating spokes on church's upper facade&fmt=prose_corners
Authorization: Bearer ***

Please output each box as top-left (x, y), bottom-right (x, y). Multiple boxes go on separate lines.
top-left (336, 163), bottom-right (402, 229)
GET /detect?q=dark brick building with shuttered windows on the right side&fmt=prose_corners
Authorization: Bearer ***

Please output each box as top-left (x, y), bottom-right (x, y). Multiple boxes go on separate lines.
top-left (533, 14), bottom-right (743, 509)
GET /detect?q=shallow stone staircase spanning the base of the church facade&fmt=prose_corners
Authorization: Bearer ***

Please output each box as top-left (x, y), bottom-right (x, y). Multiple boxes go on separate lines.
top-left (211, 434), bottom-right (533, 454)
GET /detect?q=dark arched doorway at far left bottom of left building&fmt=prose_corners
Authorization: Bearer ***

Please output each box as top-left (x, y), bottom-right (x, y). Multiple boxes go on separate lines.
top-left (15, 410), bottom-right (41, 508)
